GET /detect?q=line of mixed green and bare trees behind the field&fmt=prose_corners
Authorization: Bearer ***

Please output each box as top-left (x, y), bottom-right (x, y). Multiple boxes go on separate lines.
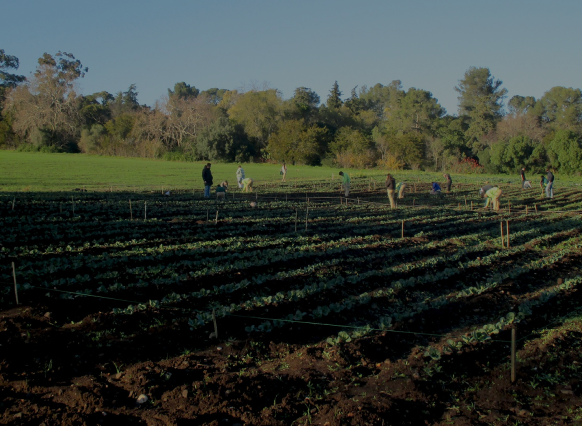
top-left (0, 49), bottom-right (582, 174)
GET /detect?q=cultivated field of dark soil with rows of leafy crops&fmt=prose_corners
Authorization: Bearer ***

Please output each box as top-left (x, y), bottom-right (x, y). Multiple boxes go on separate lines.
top-left (0, 177), bottom-right (582, 425)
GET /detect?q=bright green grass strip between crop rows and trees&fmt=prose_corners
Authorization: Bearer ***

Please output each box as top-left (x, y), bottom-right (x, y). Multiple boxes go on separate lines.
top-left (0, 151), bottom-right (580, 192)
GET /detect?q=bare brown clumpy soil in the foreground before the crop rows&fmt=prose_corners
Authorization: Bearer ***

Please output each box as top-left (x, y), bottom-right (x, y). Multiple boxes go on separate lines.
top-left (0, 295), bottom-right (582, 425)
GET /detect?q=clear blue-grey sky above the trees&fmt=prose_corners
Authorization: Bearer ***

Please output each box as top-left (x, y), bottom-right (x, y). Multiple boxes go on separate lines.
top-left (0, 0), bottom-right (582, 114)
